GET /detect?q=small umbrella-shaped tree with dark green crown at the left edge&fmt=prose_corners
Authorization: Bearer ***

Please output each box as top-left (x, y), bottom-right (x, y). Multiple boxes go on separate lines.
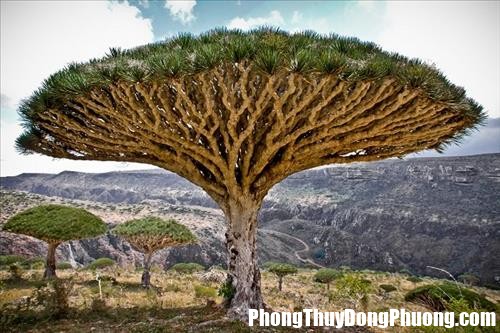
top-left (3, 205), bottom-right (107, 279)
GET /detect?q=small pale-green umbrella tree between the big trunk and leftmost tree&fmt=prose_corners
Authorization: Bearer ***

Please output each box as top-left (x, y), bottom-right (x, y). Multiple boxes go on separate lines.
top-left (112, 217), bottom-right (196, 288)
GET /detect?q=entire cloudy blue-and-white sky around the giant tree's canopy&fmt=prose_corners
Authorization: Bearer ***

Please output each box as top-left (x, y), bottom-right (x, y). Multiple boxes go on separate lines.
top-left (0, 0), bottom-right (500, 176)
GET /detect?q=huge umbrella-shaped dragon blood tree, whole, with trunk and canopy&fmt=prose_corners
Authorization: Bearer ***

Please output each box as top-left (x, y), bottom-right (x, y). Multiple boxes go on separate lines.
top-left (17, 28), bottom-right (484, 318)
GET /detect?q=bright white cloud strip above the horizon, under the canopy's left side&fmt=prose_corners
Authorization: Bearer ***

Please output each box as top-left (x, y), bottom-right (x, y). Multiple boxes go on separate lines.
top-left (0, 121), bottom-right (156, 177)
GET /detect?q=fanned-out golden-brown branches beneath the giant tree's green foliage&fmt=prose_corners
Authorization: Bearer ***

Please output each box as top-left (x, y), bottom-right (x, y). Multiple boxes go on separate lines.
top-left (28, 62), bottom-right (476, 210)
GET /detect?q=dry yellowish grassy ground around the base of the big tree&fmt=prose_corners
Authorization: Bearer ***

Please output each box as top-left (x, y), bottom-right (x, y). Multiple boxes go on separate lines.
top-left (0, 267), bottom-right (500, 333)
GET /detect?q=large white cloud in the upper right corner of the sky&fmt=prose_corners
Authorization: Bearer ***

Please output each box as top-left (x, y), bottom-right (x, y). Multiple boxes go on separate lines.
top-left (378, 1), bottom-right (500, 117)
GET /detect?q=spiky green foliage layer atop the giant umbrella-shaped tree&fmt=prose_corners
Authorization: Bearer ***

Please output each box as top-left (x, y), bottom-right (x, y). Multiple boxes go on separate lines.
top-left (17, 28), bottom-right (485, 152)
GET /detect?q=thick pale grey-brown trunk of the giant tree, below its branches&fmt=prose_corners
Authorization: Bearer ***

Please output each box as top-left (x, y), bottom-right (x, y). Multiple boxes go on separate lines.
top-left (226, 198), bottom-right (264, 322)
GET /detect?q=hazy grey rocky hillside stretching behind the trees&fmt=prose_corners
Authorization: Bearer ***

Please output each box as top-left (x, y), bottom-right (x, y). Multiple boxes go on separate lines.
top-left (0, 154), bottom-right (500, 282)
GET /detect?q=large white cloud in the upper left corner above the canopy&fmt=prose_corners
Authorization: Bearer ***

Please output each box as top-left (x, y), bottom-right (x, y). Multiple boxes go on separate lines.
top-left (0, 1), bottom-right (153, 108)
